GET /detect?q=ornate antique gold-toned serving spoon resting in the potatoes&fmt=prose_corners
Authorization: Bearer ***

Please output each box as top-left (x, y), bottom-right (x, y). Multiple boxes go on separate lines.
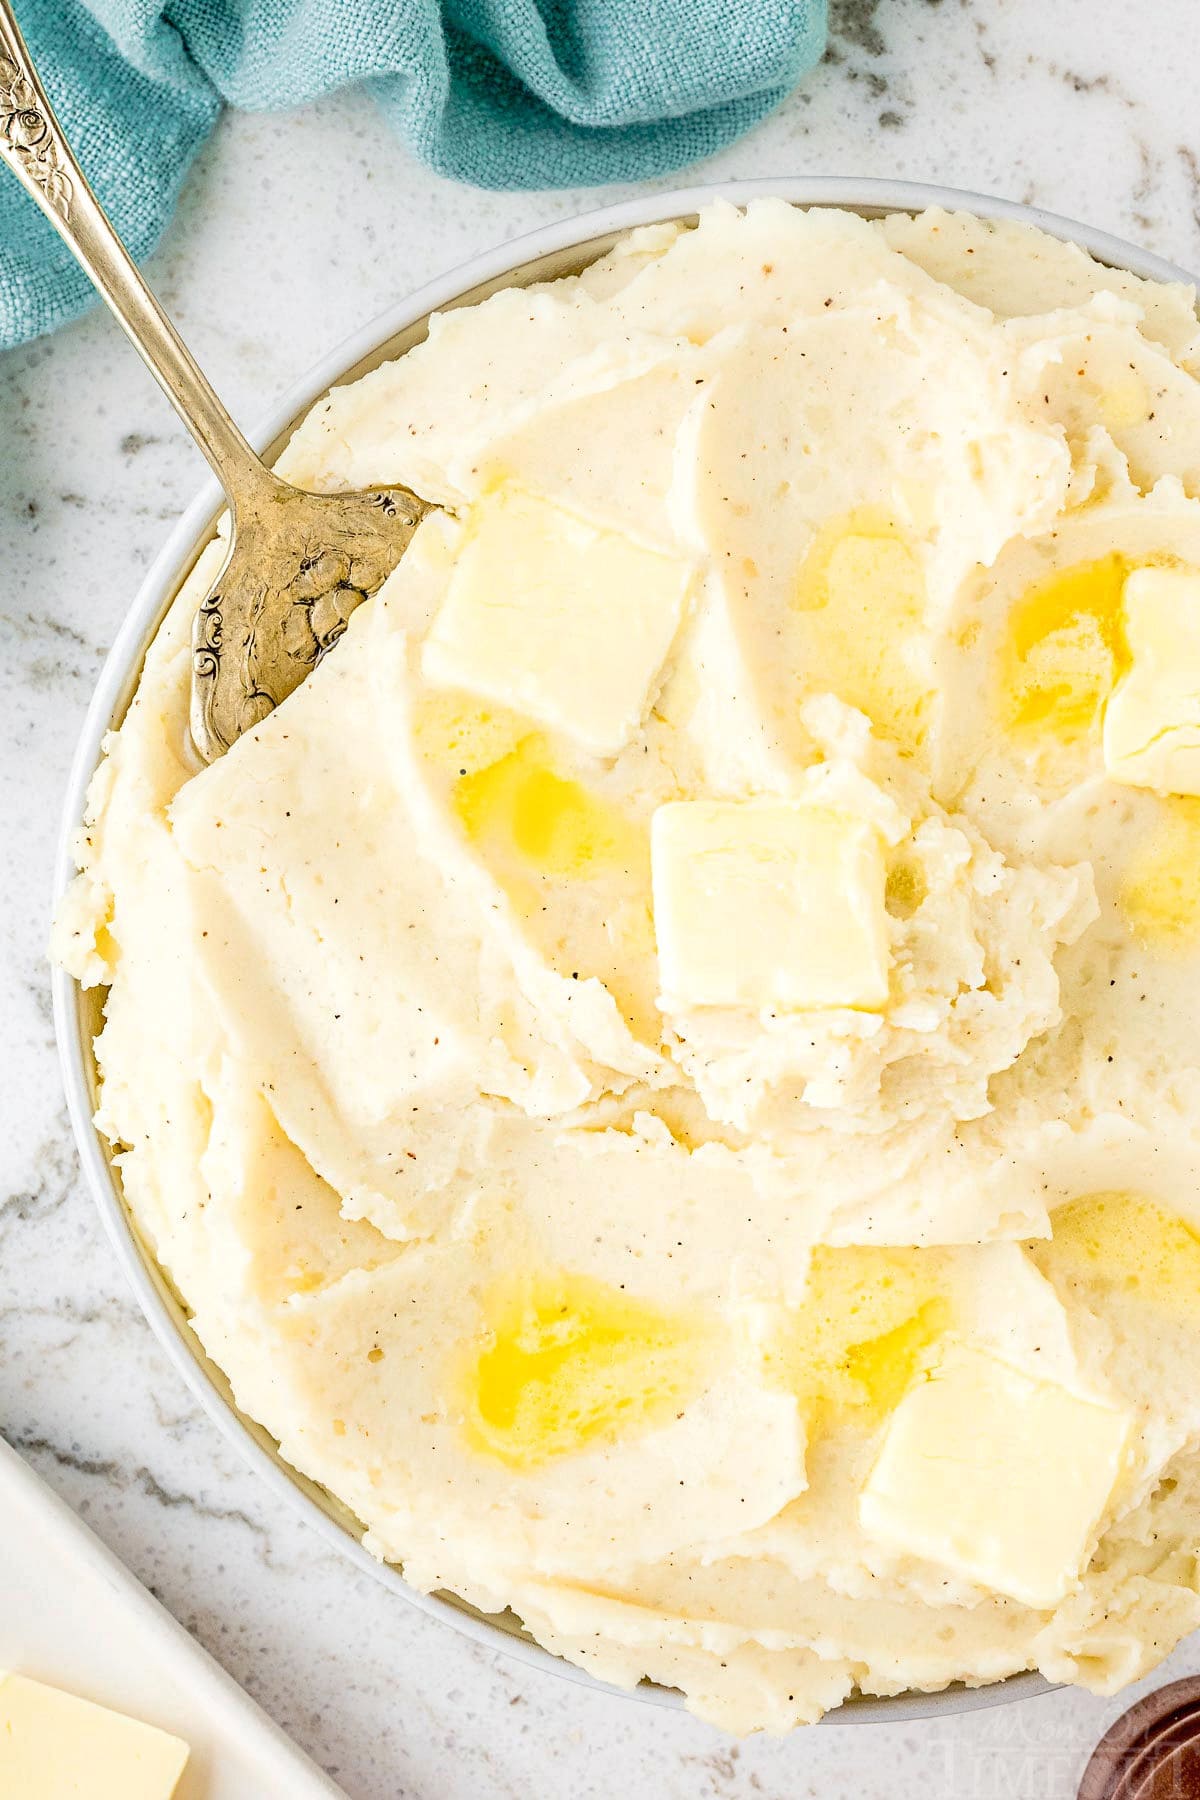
top-left (0, 0), bottom-right (430, 763)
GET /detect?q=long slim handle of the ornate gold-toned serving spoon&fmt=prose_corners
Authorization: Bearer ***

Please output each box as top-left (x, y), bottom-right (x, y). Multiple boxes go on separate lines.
top-left (0, 0), bottom-right (272, 513)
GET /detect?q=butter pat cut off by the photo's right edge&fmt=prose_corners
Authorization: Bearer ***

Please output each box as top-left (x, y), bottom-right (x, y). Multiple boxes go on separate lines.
top-left (1105, 569), bottom-right (1200, 794)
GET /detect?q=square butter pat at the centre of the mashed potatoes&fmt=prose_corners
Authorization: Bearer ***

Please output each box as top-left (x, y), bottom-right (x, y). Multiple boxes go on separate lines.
top-left (651, 799), bottom-right (891, 1010)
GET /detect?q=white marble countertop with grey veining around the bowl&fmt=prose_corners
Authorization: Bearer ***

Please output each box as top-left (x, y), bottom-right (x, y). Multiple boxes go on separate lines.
top-left (0, 0), bottom-right (1200, 1800)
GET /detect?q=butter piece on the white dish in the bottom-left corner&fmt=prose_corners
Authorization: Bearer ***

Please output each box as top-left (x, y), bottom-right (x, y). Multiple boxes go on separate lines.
top-left (0, 1676), bottom-right (187, 1800)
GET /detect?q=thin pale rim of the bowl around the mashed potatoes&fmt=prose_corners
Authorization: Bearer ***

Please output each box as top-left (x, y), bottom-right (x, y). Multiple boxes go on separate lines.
top-left (50, 175), bottom-right (1196, 1724)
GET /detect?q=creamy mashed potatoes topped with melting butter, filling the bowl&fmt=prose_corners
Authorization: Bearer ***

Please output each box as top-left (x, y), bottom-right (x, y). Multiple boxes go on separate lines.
top-left (58, 202), bottom-right (1200, 1732)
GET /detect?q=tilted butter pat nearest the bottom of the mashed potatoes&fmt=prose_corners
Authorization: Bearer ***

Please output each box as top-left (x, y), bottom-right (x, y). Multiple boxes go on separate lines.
top-left (858, 1343), bottom-right (1132, 1607)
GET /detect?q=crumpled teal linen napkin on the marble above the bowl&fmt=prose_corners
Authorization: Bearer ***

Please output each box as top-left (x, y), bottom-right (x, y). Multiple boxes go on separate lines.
top-left (0, 0), bottom-right (826, 347)
